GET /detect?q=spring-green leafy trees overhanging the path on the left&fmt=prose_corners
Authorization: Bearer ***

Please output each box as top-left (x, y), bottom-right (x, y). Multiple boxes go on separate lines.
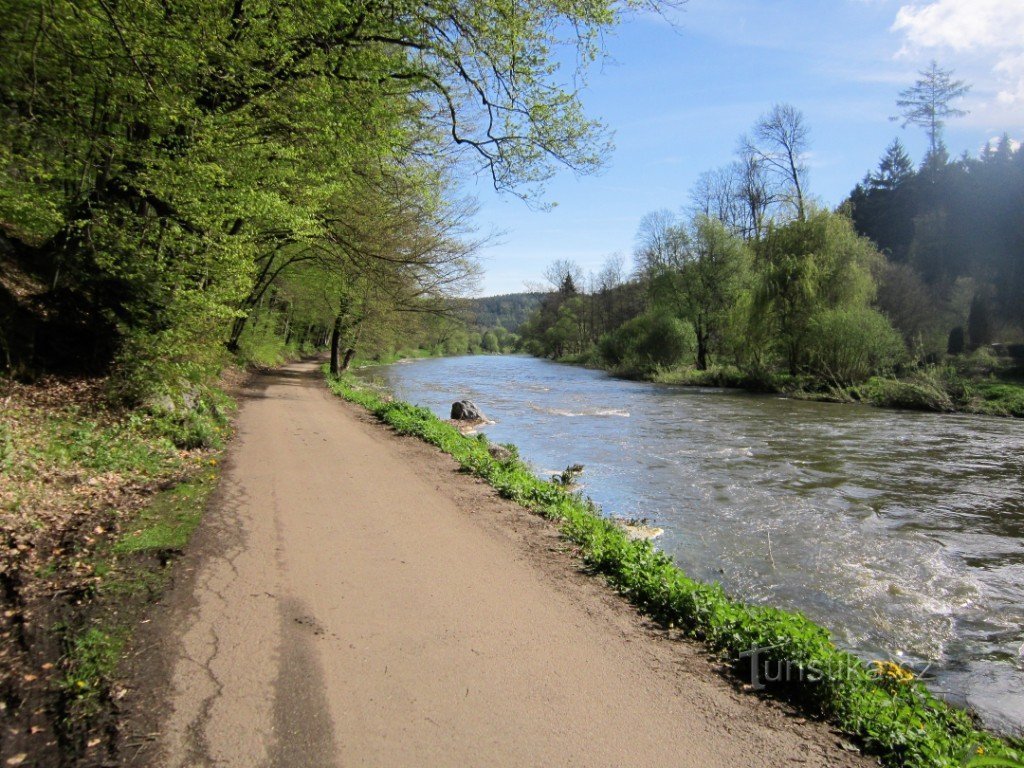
top-left (0, 0), bottom-right (641, 391)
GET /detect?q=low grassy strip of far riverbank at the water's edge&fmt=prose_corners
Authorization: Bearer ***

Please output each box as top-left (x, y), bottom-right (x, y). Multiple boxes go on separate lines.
top-left (556, 354), bottom-right (1024, 418)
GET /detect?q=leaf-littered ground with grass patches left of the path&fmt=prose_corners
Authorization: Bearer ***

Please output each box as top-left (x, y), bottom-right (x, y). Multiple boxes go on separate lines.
top-left (0, 379), bottom-right (232, 765)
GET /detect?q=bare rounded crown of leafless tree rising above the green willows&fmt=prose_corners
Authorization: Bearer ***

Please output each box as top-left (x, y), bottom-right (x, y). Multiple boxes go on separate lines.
top-left (742, 103), bottom-right (810, 221)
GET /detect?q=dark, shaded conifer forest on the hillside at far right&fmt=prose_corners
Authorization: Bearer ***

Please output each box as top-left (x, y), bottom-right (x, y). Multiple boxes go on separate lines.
top-left (850, 128), bottom-right (1024, 344)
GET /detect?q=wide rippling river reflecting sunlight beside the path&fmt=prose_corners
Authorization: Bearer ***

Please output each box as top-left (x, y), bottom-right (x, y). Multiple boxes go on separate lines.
top-left (361, 355), bottom-right (1024, 733)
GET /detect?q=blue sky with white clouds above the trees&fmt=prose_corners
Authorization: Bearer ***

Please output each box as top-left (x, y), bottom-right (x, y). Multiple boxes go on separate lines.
top-left (464, 0), bottom-right (1024, 296)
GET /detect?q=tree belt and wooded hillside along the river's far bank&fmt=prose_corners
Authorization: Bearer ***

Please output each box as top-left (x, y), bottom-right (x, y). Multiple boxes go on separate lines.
top-left (520, 69), bottom-right (1024, 415)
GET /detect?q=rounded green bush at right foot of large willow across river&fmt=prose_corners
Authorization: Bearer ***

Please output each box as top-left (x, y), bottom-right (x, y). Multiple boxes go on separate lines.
top-left (808, 307), bottom-right (906, 386)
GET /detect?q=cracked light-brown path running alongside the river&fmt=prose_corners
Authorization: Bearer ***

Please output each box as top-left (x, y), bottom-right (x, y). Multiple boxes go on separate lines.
top-left (128, 364), bottom-right (868, 768)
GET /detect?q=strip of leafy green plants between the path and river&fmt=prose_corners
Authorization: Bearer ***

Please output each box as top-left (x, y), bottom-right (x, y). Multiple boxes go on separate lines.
top-left (329, 368), bottom-right (1022, 768)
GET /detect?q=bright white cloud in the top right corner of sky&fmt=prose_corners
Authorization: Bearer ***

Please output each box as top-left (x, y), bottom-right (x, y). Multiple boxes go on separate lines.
top-left (892, 0), bottom-right (1024, 105)
